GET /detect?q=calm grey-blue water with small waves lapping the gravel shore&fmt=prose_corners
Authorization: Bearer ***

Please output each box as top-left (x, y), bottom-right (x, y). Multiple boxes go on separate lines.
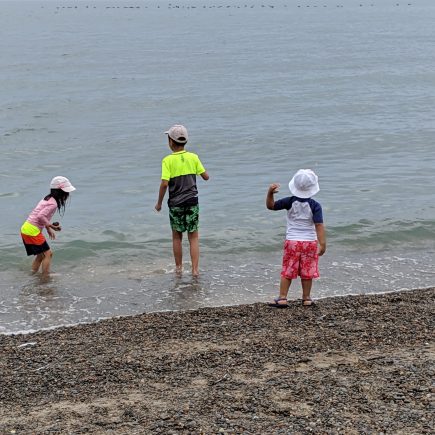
top-left (0, 0), bottom-right (435, 333)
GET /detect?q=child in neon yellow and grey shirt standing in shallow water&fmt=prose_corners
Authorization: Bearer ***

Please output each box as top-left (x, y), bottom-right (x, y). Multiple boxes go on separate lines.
top-left (155, 125), bottom-right (209, 276)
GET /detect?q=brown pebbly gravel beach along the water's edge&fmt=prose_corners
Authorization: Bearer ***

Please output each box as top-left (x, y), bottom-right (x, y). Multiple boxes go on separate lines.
top-left (0, 288), bottom-right (435, 435)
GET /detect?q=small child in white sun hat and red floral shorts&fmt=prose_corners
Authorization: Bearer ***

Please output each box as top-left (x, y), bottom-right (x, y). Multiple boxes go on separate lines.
top-left (266, 169), bottom-right (326, 308)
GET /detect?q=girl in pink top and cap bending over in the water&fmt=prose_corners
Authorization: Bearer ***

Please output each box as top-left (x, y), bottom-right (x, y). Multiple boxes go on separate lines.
top-left (21, 176), bottom-right (76, 276)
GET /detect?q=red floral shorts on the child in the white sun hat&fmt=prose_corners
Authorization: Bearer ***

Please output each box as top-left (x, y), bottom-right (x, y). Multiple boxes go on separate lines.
top-left (281, 240), bottom-right (320, 279)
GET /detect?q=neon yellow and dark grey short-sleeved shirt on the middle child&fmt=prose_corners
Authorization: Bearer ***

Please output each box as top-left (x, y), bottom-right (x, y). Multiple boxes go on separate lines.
top-left (162, 150), bottom-right (205, 207)
